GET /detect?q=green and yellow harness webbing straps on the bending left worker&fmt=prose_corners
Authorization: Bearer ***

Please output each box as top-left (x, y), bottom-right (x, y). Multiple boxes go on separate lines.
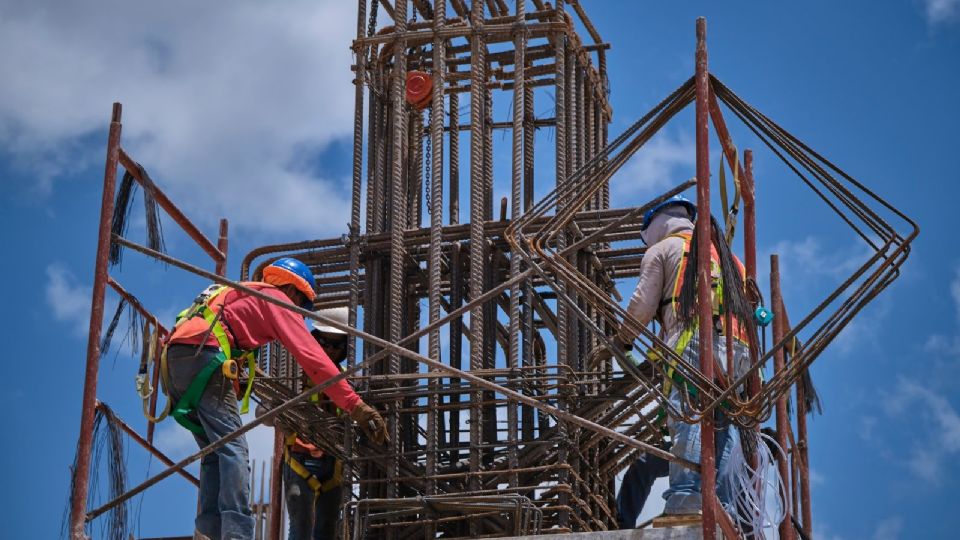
top-left (170, 286), bottom-right (257, 435)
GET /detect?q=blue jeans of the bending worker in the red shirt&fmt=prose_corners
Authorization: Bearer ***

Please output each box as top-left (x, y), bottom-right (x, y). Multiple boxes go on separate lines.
top-left (167, 345), bottom-right (254, 540)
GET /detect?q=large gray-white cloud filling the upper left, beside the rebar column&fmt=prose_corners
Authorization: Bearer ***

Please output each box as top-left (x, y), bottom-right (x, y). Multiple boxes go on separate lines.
top-left (0, 0), bottom-right (356, 236)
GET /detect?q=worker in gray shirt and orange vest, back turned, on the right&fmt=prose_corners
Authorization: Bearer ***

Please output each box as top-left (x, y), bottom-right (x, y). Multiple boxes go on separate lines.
top-left (617, 195), bottom-right (752, 514)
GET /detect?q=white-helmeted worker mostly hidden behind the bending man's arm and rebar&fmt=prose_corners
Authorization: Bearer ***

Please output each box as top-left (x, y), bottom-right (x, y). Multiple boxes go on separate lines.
top-left (283, 307), bottom-right (348, 540)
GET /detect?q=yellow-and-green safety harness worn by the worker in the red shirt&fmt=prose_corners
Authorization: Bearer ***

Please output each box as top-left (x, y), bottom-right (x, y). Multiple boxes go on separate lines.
top-left (167, 285), bottom-right (256, 435)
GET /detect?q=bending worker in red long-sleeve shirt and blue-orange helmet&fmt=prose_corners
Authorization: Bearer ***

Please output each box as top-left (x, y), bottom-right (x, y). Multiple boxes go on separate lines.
top-left (164, 257), bottom-right (387, 540)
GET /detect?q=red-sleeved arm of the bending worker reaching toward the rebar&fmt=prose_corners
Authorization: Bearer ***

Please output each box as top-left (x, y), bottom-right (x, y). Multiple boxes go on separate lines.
top-left (264, 302), bottom-right (360, 412)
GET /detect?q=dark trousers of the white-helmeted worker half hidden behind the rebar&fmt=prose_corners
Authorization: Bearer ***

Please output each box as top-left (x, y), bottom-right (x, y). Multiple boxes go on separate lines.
top-left (283, 454), bottom-right (341, 540)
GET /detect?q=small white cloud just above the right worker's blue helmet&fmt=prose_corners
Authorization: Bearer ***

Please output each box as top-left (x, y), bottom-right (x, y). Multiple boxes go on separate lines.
top-left (611, 132), bottom-right (696, 196)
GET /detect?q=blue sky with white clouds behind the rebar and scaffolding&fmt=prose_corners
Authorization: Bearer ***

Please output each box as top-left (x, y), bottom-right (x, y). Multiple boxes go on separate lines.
top-left (0, 0), bottom-right (960, 540)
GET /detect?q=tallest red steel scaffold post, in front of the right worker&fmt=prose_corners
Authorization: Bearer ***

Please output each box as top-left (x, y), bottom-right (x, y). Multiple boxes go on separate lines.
top-left (696, 17), bottom-right (717, 540)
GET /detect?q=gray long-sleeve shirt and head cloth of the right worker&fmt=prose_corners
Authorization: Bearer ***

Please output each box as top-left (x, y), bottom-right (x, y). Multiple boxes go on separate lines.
top-left (620, 209), bottom-right (693, 345)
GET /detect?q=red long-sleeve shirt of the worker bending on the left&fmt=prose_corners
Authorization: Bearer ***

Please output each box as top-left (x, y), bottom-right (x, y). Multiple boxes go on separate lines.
top-left (170, 284), bottom-right (360, 412)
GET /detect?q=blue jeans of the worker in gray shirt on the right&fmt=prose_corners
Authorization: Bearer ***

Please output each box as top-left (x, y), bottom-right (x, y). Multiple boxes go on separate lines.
top-left (663, 334), bottom-right (749, 514)
